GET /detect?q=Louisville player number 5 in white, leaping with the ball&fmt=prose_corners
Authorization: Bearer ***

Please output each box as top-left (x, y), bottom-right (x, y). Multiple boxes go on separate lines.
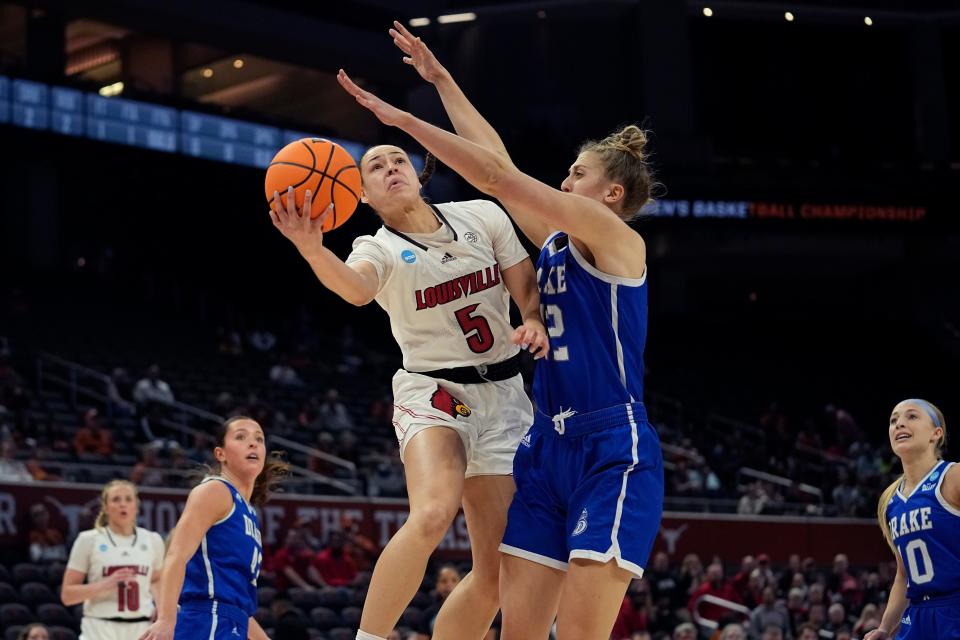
top-left (271, 140), bottom-right (547, 640)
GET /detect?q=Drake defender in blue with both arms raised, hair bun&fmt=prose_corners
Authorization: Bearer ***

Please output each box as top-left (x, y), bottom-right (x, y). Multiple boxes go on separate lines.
top-left (338, 22), bottom-right (663, 640)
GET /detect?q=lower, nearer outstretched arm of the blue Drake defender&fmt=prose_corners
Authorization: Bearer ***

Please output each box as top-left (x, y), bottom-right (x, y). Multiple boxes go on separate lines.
top-left (337, 69), bottom-right (646, 278)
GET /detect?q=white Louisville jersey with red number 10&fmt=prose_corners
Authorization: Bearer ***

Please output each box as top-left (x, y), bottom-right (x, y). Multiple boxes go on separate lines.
top-left (67, 527), bottom-right (164, 618)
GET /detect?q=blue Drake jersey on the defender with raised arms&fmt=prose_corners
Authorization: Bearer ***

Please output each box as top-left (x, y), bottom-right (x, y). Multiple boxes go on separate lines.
top-left (533, 233), bottom-right (647, 415)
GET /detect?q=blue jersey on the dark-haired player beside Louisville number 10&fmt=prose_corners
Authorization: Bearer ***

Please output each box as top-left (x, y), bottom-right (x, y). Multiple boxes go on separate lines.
top-left (180, 476), bottom-right (263, 616)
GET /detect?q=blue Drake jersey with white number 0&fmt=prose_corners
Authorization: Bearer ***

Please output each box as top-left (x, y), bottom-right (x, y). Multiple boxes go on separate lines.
top-left (887, 460), bottom-right (960, 602)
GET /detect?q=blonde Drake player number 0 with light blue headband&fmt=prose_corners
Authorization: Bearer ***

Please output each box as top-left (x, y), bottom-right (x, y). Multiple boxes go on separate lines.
top-left (865, 399), bottom-right (960, 640)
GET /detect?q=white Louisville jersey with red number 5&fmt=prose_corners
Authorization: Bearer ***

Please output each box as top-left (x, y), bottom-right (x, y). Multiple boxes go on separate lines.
top-left (347, 200), bottom-right (529, 371)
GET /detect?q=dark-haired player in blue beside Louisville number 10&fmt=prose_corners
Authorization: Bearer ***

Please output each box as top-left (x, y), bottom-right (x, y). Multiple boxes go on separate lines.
top-left (141, 416), bottom-right (289, 640)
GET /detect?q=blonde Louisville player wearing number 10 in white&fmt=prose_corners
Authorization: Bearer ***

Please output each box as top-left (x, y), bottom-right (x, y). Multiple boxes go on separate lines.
top-left (60, 480), bottom-right (164, 640)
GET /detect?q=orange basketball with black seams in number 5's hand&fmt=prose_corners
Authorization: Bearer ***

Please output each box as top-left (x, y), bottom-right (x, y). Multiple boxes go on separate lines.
top-left (264, 138), bottom-right (360, 232)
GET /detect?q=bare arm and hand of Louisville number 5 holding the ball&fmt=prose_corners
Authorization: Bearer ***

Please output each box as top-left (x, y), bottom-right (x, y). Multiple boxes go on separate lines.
top-left (270, 187), bottom-right (378, 306)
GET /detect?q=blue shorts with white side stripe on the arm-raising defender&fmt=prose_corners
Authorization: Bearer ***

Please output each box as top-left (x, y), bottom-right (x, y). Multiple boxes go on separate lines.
top-left (500, 403), bottom-right (663, 578)
